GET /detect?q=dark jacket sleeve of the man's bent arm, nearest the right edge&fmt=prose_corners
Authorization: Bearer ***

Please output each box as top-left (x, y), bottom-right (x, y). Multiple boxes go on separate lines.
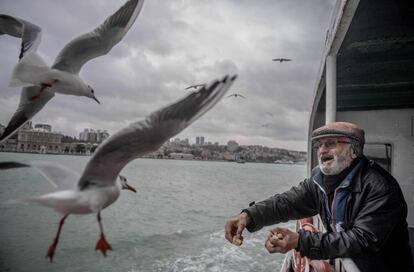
top-left (298, 169), bottom-right (407, 259)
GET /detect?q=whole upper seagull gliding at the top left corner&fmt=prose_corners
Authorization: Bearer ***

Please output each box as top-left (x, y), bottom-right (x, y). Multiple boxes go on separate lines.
top-left (0, 0), bottom-right (144, 143)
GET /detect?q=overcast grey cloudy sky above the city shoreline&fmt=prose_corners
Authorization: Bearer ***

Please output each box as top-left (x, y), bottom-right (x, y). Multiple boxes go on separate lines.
top-left (0, 0), bottom-right (334, 150)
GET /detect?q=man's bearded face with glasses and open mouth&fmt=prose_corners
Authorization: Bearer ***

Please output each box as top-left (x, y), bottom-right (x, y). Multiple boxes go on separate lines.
top-left (315, 137), bottom-right (356, 176)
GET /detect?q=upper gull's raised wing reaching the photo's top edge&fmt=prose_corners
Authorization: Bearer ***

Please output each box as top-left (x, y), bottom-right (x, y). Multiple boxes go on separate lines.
top-left (52, 0), bottom-right (144, 74)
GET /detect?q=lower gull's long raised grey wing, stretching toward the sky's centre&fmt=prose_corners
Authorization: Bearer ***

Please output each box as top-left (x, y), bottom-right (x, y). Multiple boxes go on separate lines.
top-left (78, 76), bottom-right (236, 189)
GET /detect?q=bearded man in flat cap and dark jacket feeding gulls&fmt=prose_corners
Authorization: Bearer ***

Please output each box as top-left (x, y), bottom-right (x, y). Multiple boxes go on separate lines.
top-left (225, 122), bottom-right (414, 271)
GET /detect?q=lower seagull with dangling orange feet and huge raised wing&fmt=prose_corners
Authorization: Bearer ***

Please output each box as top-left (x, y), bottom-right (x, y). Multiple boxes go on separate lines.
top-left (0, 75), bottom-right (236, 262)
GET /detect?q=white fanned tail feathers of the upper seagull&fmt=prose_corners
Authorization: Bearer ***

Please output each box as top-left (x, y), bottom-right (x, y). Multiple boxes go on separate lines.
top-left (9, 52), bottom-right (49, 87)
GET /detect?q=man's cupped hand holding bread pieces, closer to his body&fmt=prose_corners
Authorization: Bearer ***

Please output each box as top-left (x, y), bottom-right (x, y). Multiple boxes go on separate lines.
top-left (265, 228), bottom-right (299, 253)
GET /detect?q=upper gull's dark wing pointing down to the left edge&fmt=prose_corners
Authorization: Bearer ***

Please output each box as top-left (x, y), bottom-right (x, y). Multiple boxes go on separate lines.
top-left (0, 86), bottom-right (55, 143)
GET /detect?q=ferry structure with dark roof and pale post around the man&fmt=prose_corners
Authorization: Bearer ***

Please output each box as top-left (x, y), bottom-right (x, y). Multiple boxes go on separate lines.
top-left (281, 0), bottom-right (414, 272)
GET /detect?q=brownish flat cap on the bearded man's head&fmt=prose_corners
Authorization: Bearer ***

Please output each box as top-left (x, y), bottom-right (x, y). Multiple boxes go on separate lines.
top-left (312, 122), bottom-right (365, 146)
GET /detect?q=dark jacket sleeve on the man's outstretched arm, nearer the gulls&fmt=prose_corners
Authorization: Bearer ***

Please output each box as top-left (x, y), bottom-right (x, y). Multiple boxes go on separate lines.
top-left (243, 179), bottom-right (319, 232)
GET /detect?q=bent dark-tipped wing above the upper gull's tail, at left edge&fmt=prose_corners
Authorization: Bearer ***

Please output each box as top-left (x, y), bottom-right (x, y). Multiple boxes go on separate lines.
top-left (0, 14), bottom-right (42, 59)
